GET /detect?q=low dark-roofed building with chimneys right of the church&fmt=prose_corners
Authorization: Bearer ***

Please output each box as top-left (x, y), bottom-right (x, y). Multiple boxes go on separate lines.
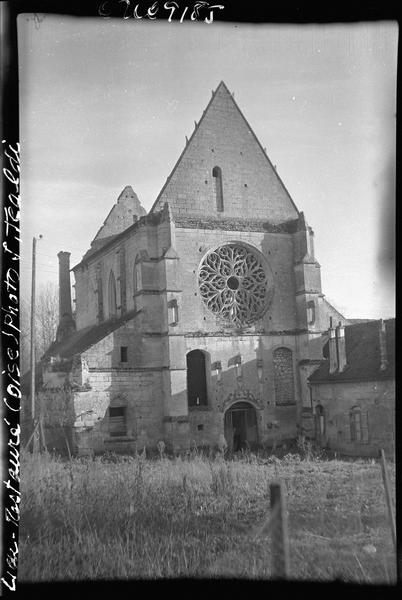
top-left (309, 319), bottom-right (395, 457)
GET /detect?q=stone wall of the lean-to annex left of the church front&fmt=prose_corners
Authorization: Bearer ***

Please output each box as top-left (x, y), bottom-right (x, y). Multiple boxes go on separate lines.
top-left (40, 320), bottom-right (167, 454)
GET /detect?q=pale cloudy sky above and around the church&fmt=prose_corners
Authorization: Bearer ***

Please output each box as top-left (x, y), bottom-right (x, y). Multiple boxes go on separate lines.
top-left (18, 15), bottom-right (398, 318)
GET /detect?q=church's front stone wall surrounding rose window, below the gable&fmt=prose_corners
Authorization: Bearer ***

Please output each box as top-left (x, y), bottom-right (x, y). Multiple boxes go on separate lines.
top-left (157, 227), bottom-right (321, 446)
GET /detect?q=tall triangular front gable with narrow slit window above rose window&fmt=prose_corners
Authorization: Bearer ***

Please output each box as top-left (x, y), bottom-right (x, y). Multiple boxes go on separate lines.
top-left (151, 82), bottom-right (298, 224)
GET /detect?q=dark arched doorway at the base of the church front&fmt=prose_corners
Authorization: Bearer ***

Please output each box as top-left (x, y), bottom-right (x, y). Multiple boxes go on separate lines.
top-left (225, 402), bottom-right (258, 452)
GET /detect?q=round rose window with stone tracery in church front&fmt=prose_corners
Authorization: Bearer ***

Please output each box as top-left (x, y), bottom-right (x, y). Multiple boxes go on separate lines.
top-left (198, 243), bottom-right (270, 326)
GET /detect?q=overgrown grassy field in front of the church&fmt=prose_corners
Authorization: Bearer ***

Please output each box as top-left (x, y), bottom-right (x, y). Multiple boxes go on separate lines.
top-left (18, 454), bottom-right (396, 584)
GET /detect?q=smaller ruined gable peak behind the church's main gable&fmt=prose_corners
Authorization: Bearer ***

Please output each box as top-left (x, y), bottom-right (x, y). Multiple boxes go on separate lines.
top-left (91, 185), bottom-right (146, 246)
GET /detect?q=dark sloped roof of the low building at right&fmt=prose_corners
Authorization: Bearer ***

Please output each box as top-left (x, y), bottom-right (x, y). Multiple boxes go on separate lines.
top-left (309, 319), bottom-right (395, 383)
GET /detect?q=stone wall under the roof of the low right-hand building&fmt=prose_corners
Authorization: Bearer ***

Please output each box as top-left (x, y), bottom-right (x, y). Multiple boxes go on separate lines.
top-left (312, 380), bottom-right (395, 457)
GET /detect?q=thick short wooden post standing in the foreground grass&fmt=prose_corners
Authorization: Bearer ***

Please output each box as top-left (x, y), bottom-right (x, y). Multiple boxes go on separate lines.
top-left (269, 481), bottom-right (289, 579)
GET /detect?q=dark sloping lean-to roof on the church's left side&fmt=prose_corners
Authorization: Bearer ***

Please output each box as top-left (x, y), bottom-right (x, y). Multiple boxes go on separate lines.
top-left (43, 310), bottom-right (140, 359)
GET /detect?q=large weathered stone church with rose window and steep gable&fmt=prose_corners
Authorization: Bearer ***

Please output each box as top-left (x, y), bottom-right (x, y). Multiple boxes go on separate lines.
top-left (28, 82), bottom-right (347, 453)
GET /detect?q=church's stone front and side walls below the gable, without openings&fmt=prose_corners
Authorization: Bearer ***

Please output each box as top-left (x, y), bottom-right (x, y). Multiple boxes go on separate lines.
top-left (55, 213), bottom-right (338, 452)
